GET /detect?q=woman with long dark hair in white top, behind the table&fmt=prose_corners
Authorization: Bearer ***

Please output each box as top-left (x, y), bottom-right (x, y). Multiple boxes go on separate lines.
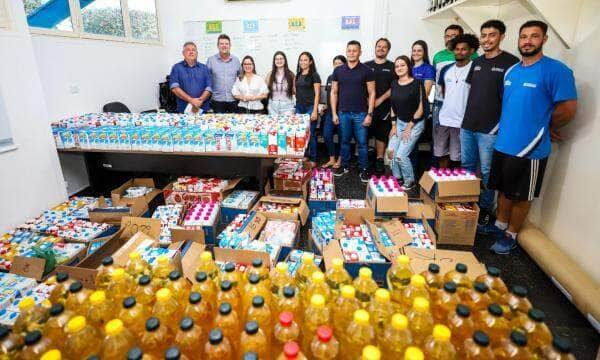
top-left (267, 51), bottom-right (294, 115)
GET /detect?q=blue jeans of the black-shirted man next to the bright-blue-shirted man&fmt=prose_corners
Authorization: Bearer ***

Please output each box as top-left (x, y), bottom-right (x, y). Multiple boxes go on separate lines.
top-left (460, 129), bottom-right (496, 211)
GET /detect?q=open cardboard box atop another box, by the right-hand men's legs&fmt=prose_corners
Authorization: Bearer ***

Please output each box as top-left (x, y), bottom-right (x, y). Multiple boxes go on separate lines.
top-left (419, 171), bottom-right (481, 203)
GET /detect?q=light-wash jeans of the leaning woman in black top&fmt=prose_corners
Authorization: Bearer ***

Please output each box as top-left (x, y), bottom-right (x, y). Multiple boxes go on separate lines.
top-left (388, 119), bottom-right (425, 184)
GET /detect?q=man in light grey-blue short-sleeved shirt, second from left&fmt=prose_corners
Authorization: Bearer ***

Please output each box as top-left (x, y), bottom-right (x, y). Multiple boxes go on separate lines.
top-left (206, 34), bottom-right (241, 114)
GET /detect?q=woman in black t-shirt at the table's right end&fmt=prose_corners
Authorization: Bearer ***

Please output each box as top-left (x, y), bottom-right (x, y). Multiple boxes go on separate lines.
top-left (295, 51), bottom-right (321, 167)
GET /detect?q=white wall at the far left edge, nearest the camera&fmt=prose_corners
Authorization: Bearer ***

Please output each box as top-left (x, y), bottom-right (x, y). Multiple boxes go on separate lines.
top-left (0, 0), bottom-right (66, 233)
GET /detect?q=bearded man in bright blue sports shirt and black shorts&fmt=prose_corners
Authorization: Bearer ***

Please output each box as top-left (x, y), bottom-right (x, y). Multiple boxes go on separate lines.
top-left (489, 20), bottom-right (577, 254)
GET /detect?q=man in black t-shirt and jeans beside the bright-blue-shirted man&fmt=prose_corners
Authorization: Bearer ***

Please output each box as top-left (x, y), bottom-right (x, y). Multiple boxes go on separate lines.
top-left (460, 20), bottom-right (519, 232)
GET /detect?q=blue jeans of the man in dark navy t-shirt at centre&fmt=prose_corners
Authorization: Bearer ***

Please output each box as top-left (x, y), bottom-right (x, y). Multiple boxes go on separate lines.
top-left (339, 111), bottom-right (369, 171)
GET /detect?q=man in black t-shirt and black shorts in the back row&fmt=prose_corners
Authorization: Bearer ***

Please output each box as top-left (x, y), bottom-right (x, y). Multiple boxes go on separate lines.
top-left (365, 38), bottom-right (394, 174)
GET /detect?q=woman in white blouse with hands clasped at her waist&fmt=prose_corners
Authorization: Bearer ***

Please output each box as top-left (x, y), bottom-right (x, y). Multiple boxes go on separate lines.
top-left (231, 55), bottom-right (269, 114)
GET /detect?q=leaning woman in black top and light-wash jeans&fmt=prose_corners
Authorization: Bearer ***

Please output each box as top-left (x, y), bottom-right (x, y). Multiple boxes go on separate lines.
top-left (388, 55), bottom-right (425, 191)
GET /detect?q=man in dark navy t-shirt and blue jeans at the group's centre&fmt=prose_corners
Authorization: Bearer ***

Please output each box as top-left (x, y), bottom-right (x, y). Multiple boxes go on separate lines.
top-left (331, 40), bottom-right (375, 182)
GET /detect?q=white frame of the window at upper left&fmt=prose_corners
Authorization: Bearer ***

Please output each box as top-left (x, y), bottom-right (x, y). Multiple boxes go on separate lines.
top-left (27, 0), bottom-right (163, 46)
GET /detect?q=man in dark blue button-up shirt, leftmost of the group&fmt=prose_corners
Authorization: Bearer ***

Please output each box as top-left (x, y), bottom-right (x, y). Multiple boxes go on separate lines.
top-left (169, 41), bottom-right (212, 113)
